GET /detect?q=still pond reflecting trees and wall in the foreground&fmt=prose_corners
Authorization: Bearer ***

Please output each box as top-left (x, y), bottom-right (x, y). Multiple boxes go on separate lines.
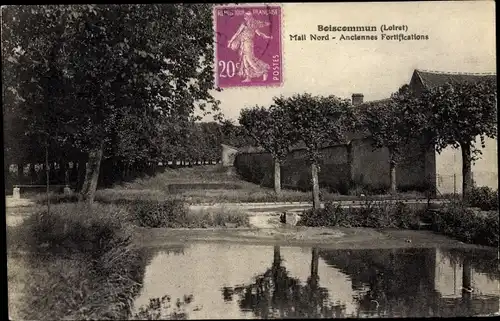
top-left (134, 243), bottom-right (500, 319)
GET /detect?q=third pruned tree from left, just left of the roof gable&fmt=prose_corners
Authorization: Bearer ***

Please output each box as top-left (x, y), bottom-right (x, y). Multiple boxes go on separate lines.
top-left (357, 85), bottom-right (426, 193)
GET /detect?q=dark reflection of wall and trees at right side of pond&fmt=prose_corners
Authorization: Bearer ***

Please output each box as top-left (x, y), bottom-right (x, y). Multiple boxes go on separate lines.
top-left (321, 249), bottom-right (498, 317)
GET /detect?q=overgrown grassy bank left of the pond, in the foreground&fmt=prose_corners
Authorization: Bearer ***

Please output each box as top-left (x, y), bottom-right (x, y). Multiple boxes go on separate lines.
top-left (7, 204), bottom-right (147, 320)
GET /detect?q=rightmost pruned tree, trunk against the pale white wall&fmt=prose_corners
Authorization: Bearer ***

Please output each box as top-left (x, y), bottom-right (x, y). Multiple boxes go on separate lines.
top-left (422, 80), bottom-right (497, 200)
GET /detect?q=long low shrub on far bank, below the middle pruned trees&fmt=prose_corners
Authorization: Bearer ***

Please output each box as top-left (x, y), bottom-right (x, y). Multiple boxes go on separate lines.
top-left (297, 201), bottom-right (423, 228)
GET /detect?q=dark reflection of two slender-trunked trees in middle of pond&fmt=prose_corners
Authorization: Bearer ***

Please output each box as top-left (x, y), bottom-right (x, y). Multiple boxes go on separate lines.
top-left (222, 246), bottom-right (345, 318)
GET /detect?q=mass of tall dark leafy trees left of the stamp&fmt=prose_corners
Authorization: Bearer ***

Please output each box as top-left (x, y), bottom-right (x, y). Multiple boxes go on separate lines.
top-left (2, 4), bottom-right (254, 202)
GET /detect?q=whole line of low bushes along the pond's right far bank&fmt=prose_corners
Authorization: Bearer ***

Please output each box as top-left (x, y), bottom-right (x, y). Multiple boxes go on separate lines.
top-left (297, 201), bottom-right (499, 247)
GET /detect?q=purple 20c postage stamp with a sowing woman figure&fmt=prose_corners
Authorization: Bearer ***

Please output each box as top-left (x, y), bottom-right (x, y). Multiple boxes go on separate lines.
top-left (214, 5), bottom-right (283, 88)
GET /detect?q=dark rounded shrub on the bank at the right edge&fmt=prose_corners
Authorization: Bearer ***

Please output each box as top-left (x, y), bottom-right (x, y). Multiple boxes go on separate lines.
top-left (432, 202), bottom-right (499, 246)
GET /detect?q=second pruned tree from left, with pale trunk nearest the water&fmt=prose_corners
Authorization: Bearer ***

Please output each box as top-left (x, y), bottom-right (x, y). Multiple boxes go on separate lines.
top-left (275, 94), bottom-right (354, 209)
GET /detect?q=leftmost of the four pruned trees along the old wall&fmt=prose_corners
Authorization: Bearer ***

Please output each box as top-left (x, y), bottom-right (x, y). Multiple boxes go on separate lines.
top-left (239, 106), bottom-right (292, 195)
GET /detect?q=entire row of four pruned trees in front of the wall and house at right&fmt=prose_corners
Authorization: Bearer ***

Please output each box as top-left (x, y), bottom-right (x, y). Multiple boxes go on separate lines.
top-left (239, 80), bottom-right (497, 208)
